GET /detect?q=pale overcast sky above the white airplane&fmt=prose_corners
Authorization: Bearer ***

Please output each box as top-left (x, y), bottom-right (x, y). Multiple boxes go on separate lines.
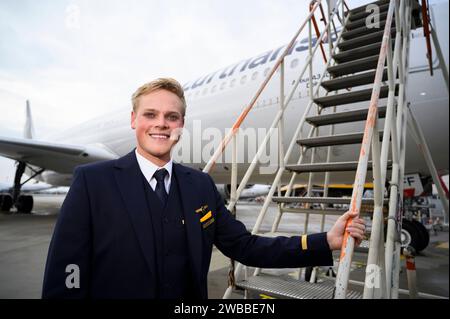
top-left (0, 0), bottom-right (376, 135)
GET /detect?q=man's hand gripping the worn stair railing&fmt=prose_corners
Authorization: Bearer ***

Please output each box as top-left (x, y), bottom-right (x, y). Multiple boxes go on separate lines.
top-left (327, 211), bottom-right (366, 250)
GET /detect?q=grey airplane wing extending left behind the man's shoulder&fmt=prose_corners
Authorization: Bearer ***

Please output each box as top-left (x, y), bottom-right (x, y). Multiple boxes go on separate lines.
top-left (0, 136), bottom-right (119, 173)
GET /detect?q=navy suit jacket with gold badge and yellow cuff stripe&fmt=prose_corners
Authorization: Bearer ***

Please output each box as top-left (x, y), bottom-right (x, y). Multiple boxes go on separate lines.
top-left (42, 151), bottom-right (332, 298)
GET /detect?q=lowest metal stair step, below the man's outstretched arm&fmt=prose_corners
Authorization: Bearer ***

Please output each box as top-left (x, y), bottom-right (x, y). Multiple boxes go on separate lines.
top-left (236, 274), bottom-right (362, 299)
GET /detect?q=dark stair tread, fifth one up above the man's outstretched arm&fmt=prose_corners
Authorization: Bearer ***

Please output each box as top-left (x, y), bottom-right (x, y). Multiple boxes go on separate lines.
top-left (314, 84), bottom-right (398, 107)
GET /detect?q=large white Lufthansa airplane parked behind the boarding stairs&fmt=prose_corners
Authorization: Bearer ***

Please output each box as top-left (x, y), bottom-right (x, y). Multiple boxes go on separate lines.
top-left (0, 1), bottom-right (449, 212)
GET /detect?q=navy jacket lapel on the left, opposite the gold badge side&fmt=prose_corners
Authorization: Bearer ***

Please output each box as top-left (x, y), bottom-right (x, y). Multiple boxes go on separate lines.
top-left (114, 150), bottom-right (156, 275)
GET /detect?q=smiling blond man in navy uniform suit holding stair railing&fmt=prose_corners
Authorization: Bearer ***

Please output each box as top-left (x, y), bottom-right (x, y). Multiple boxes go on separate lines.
top-left (42, 79), bottom-right (365, 299)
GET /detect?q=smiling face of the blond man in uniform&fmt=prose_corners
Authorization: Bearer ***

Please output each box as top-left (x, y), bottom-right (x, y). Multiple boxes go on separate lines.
top-left (131, 89), bottom-right (184, 167)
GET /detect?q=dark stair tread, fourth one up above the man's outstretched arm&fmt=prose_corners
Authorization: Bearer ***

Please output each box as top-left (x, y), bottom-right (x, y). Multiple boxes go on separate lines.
top-left (306, 106), bottom-right (386, 126)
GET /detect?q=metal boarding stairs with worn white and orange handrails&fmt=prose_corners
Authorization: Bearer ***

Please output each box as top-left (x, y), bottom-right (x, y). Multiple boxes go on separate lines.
top-left (204, 0), bottom-right (450, 299)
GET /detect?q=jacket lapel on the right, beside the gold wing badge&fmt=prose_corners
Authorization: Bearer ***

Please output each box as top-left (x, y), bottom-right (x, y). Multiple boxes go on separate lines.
top-left (173, 163), bottom-right (203, 285)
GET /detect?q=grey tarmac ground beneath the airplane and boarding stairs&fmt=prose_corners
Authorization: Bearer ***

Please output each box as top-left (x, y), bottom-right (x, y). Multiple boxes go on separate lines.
top-left (0, 195), bottom-right (449, 299)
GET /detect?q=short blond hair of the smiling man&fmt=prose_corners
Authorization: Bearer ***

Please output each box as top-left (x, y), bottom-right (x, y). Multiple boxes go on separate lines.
top-left (131, 78), bottom-right (186, 117)
